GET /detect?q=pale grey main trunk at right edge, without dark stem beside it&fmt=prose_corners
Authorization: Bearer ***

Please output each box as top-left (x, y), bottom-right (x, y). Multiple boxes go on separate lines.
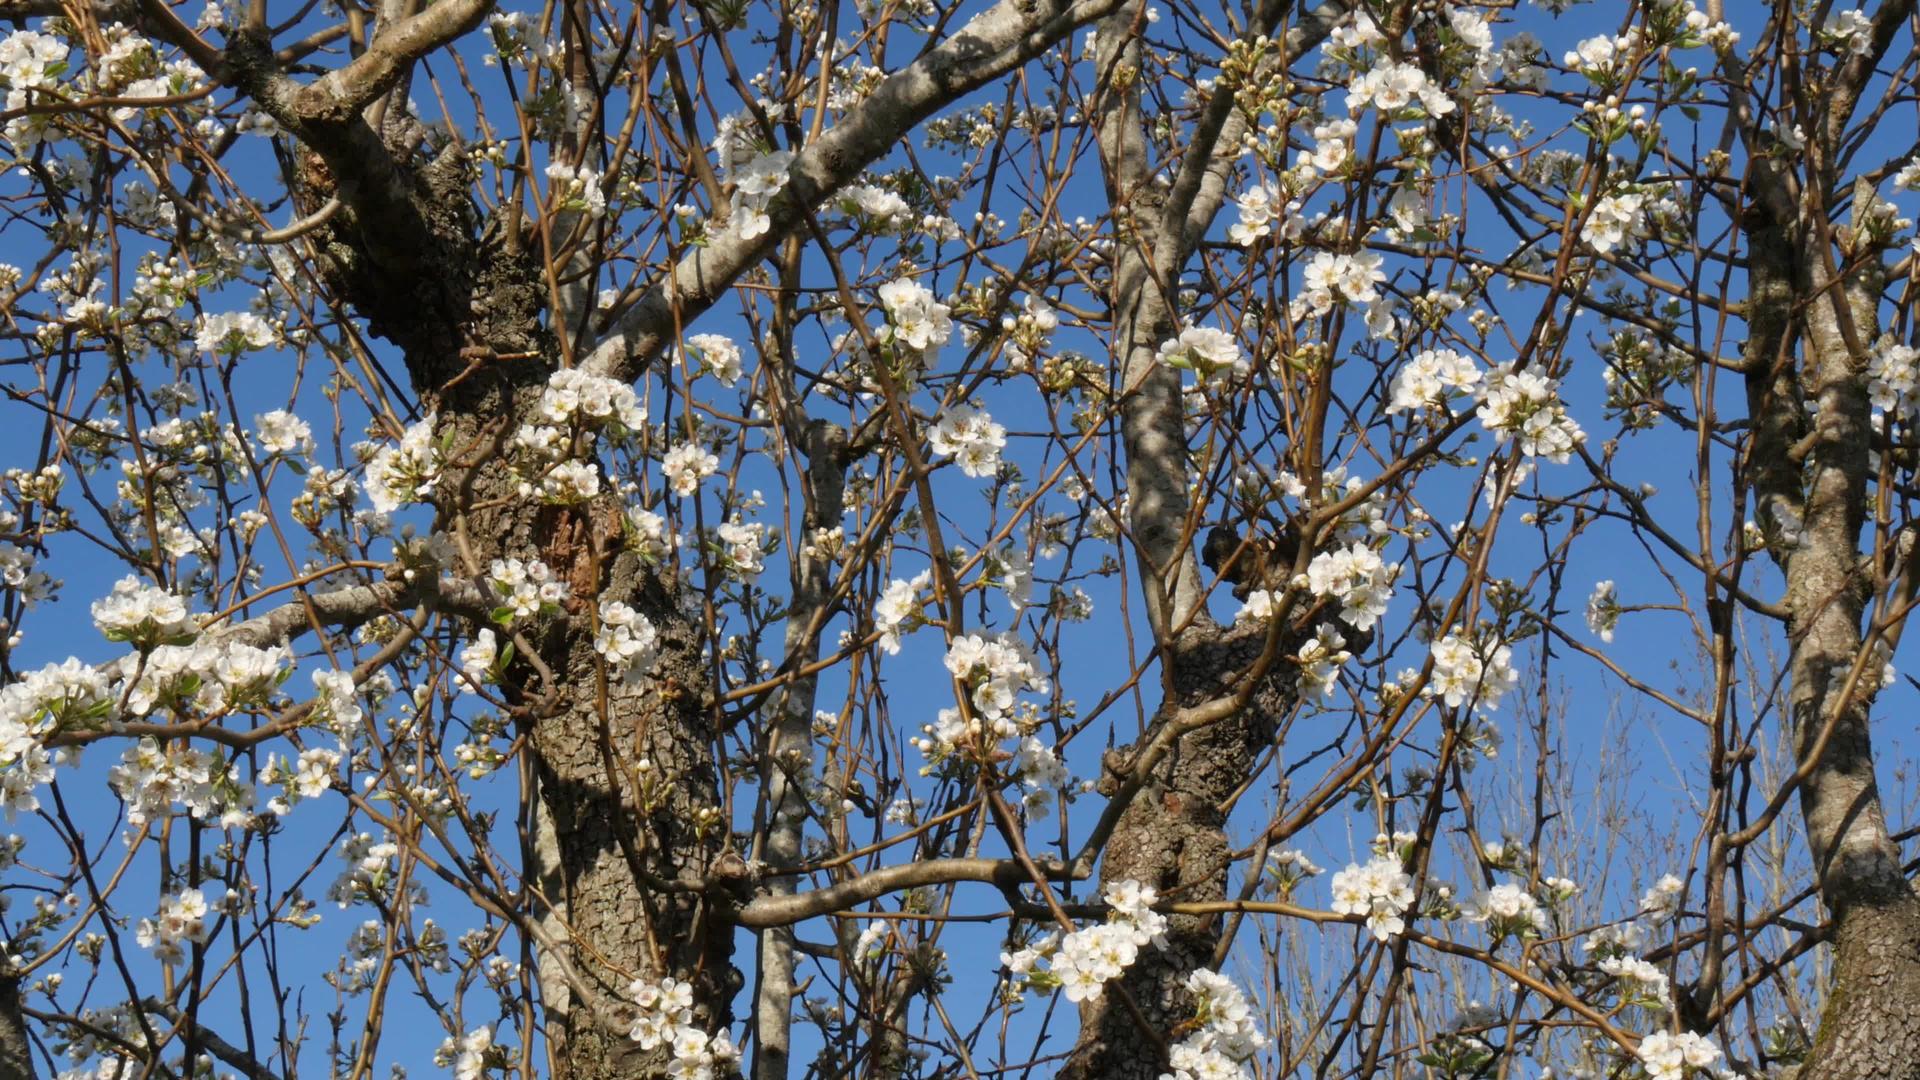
top-left (1757, 188), bottom-right (1920, 1078)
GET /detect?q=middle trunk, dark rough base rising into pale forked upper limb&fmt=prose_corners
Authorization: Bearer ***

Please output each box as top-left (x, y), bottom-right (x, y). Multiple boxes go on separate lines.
top-left (1060, 0), bottom-right (1348, 1080)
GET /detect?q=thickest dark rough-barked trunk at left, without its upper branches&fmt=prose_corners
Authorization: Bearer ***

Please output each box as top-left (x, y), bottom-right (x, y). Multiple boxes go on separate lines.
top-left (295, 113), bottom-right (739, 1080)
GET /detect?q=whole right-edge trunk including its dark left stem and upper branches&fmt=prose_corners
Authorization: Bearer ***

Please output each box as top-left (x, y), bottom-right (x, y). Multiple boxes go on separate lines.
top-left (1743, 2), bottom-right (1920, 1060)
